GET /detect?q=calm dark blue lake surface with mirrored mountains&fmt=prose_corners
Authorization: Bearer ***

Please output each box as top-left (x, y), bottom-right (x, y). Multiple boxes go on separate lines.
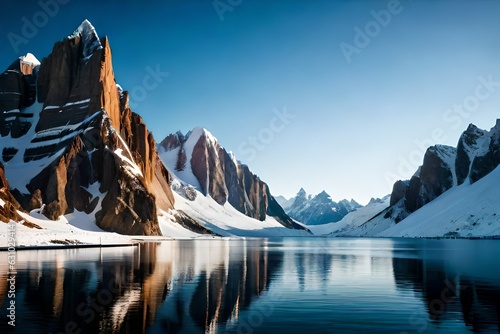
top-left (0, 238), bottom-right (500, 334)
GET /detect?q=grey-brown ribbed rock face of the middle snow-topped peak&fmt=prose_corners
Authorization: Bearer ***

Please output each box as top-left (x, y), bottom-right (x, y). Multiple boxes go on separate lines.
top-left (159, 128), bottom-right (303, 229)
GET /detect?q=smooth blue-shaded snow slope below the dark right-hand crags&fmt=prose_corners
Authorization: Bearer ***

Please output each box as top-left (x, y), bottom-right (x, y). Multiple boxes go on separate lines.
top-left (376, 167), bottom-right (500, 237)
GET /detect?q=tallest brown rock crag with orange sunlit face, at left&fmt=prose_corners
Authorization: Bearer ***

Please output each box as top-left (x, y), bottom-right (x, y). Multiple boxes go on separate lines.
top-left (0, 21), bottom-right (174, 235)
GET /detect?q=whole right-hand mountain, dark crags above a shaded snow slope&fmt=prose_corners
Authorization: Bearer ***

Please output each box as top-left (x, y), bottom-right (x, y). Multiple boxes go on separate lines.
top-left (343, 120), bottom-right (500, 237)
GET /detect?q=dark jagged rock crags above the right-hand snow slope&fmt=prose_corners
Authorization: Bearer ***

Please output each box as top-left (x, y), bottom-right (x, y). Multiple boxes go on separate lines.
top-left (384, 120), bottom-right (500, 223)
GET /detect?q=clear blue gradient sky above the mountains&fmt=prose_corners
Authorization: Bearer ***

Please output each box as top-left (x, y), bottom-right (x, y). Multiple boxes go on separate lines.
top-left (0, 0), bottom-right (500, 204)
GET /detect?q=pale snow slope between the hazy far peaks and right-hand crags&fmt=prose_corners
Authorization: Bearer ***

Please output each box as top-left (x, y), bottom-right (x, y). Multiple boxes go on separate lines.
top-left (308, 195), bottom-right (390, 236)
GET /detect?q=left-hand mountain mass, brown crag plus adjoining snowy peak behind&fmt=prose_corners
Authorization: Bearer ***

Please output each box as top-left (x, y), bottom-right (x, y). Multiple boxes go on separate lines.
top-left (0, 20), bottom-right (309, 241)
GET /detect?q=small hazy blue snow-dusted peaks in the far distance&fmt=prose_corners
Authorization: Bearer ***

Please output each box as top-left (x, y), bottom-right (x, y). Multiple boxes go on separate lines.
top-left (283, 188), bottom-right (362, 226)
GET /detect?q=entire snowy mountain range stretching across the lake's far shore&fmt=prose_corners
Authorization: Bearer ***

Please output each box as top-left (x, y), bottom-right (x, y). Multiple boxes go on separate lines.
top-left (0, 20), bottom-right (500, 242)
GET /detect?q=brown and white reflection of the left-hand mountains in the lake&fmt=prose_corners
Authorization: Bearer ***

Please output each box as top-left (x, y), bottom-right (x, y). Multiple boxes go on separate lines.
top-left (2, 240), bottom-right (282, 333)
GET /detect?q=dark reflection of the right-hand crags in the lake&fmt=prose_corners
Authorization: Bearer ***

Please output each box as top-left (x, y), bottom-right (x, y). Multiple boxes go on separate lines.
top-left (393, 254), bottom-right (500, 332)
